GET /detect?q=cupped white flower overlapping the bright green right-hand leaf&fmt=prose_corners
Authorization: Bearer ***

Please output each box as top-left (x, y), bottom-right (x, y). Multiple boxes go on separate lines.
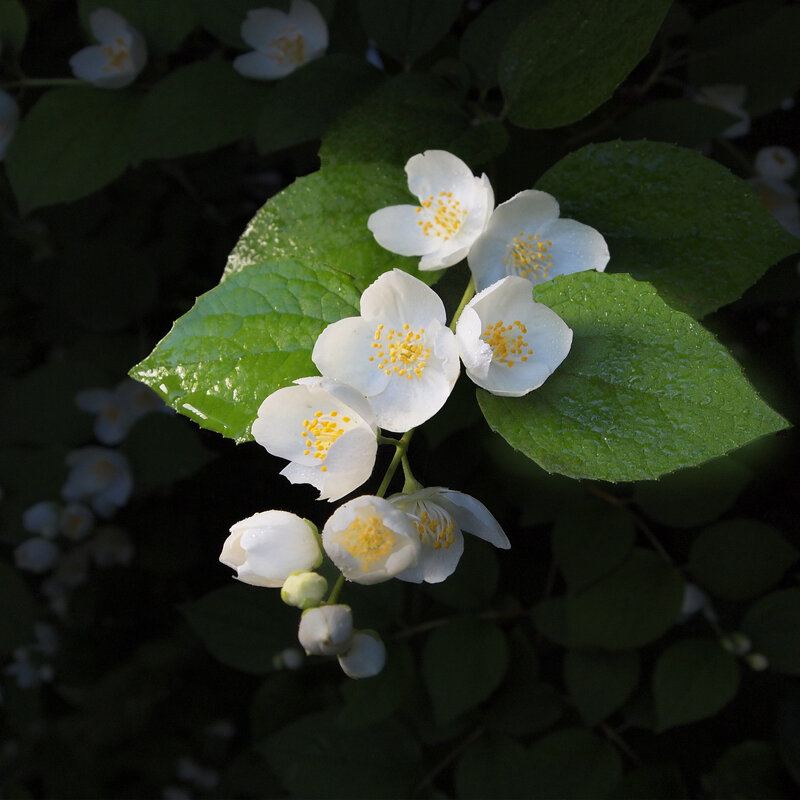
top-left (456, 275), bottom-right (572, 397)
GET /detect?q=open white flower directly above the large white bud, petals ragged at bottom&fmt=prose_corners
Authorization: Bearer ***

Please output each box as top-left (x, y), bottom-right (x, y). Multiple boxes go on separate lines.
top-left (252, 378), bottom-right (378, 500)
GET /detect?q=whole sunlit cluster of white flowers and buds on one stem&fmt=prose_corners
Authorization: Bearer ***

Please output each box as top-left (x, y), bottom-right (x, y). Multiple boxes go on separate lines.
top-left (220, 148), bottom-right (609, 678)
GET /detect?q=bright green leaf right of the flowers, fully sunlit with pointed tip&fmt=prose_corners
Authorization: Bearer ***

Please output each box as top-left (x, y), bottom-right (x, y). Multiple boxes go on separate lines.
top-left (478, 271), bottom-right (786, 481)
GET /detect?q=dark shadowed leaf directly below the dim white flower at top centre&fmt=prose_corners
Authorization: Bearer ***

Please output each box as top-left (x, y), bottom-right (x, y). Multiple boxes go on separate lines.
top-left (256, 55), bottom-right (381, 153)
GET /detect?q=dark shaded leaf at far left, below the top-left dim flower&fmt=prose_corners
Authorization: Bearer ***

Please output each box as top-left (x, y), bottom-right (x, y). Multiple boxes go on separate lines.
top-left (6, 86), bottom-right (137, 214)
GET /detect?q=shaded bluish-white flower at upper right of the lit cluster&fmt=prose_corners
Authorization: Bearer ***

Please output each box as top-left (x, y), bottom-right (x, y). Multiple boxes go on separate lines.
top-left (468, 189), bottom-right (609, 291)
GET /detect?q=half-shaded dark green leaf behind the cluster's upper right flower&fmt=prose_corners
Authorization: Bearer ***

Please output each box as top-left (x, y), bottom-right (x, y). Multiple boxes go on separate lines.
top-left (536, 142), bottom-right (800, 319)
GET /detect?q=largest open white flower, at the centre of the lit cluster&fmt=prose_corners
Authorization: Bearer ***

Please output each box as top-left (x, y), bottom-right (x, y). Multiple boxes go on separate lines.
top-left (311, 269), bottom-right (460, 431)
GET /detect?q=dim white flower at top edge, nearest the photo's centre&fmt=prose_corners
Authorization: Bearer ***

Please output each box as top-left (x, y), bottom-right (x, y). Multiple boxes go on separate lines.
top-left (233, 0), bottom-right (328, 80)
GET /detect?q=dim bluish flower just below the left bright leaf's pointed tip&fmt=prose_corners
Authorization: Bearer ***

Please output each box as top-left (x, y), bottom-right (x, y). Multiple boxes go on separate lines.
top-left (75, 378), bottom-right (165, 444)
